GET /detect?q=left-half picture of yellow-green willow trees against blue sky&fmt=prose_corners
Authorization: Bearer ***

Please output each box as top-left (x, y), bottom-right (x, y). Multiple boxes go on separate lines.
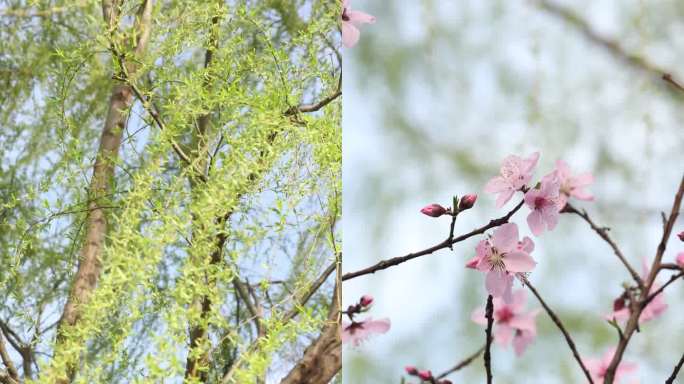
top-left (0, 0), bottom-right (341, 383)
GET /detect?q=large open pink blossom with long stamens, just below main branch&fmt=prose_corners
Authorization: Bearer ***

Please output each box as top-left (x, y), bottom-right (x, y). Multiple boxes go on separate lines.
top-left (466, 223), bottom-right (537, 301)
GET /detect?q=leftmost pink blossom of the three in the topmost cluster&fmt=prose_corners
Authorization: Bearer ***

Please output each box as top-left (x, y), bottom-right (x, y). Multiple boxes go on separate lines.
top-left (484, 152), bottom-right (539, 208)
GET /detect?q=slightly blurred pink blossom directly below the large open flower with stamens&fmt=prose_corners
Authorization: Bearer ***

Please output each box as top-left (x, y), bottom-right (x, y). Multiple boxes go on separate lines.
top-left (471, 289), bottom-right (539, 357)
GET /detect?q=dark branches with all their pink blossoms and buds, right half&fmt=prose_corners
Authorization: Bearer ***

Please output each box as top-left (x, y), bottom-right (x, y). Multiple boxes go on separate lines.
top-left (342, 149), bottom-right (684, 384)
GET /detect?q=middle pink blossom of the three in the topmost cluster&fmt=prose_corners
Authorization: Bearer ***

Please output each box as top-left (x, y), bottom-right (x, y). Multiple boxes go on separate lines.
top-left (525, 171), bottom-right (560, 236)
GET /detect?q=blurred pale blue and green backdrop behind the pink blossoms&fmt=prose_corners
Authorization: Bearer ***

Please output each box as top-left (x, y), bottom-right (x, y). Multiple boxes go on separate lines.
top-left (343, 0), bottom-right (684, 384)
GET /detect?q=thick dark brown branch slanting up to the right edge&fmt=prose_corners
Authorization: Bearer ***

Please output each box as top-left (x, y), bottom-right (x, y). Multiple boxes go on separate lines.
top-left (604, 175), bottom-right (684, 384)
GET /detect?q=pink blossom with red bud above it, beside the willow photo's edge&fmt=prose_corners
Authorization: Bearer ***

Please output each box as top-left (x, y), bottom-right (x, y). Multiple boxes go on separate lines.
top-left (340, 295), bottom-right (391, 347)
